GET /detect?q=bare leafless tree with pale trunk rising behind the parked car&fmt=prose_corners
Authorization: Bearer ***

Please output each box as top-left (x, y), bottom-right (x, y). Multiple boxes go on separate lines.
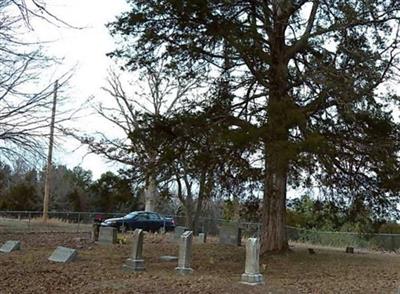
top-left (80, 64), bottom-right (199, 211)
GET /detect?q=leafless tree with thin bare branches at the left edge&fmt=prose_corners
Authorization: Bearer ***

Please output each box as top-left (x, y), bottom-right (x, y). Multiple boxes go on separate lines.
top-left (0, 0), bottom-right (73, 160)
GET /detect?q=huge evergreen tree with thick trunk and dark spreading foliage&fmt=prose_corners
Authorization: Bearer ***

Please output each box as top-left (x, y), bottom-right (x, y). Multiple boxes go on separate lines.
top-left (109, 0), bottom-right (400, 253)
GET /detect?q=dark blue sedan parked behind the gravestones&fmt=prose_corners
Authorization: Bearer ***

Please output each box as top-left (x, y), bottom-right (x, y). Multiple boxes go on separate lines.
top-left (101, 211), bottom-right (175, 232)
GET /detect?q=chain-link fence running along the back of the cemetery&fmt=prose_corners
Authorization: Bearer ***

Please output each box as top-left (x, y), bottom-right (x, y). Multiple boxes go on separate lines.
top-left (0, 211), bottom-right (400, 251)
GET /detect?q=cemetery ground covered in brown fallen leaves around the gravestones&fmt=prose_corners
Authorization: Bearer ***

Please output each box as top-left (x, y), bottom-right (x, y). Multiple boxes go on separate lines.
top-left (0, 233), bottom-right (400, 294)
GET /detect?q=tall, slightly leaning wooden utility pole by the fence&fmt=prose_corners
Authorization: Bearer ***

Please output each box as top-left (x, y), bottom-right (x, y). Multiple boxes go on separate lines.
top-left (43, 80), bottom-right (58, 222)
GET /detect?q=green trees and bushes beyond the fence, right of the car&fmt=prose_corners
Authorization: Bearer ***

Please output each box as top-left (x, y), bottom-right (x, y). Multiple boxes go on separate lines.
top-left (224, 194), bottom-right (400, 235)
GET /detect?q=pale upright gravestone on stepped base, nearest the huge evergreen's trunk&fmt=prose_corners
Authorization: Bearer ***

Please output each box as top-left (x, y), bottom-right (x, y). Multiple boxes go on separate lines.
top-left (241, 238), bottom-right (264, 286)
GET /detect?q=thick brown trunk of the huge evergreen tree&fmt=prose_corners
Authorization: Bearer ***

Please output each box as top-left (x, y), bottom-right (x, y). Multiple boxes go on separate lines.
top-left (261, 15), bottom-right (290, 254)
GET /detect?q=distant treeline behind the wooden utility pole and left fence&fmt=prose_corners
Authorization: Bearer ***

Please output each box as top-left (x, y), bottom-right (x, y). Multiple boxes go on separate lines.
top-left (0, 162), bottom-right (143, 212)
